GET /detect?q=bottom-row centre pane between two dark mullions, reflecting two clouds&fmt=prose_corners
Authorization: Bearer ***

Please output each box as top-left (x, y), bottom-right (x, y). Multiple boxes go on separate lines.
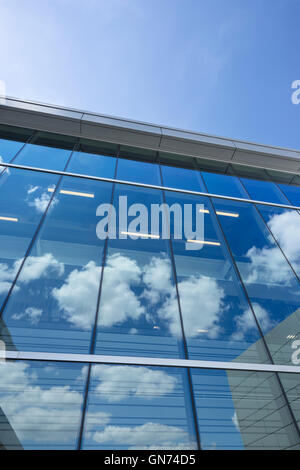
top-left (83, 364), bottom-right (196, 450)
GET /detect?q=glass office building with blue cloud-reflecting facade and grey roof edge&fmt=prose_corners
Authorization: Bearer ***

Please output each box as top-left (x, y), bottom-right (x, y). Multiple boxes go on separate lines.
top-left (0, 99), bottom-right (300, 450)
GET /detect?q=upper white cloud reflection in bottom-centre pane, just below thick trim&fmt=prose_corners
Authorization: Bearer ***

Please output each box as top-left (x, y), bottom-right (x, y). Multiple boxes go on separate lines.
top-left (93, 364), bottom-right (177, 402)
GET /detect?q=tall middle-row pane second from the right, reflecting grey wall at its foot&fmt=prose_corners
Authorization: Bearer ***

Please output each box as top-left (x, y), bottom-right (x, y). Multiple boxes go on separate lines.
top-left (214, 199), bottom-right (300, 365)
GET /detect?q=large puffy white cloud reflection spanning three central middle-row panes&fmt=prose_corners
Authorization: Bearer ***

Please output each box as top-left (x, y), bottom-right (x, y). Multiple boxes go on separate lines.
top-left (52, 253), bottom-right (225, 338)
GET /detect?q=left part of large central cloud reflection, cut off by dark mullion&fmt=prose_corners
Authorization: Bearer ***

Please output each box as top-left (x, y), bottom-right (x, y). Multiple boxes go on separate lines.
top-left (52, 261), bottom-right (100, 330)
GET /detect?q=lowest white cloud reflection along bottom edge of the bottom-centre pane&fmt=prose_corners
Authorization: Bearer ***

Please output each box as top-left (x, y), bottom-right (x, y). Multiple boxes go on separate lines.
top-left (93, 421), bottom-right (195, 449)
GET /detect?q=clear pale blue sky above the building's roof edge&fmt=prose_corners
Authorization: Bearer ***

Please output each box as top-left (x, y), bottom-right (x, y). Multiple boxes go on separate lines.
top-left (0, 0), bottom-right (300, 149)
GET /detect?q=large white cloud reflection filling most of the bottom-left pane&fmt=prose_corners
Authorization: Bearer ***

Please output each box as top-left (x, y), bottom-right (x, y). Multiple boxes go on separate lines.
top-left (0, 361), bottom-right (110, 443)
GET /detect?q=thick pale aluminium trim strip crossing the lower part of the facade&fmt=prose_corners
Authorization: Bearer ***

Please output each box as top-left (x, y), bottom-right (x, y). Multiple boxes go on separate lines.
top-left (0, 351), bottom-right (300, 374)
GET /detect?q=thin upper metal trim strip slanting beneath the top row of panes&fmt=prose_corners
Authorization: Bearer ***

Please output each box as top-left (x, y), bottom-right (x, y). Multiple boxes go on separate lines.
top-left (0, 162), bottom-right (300, 211)
